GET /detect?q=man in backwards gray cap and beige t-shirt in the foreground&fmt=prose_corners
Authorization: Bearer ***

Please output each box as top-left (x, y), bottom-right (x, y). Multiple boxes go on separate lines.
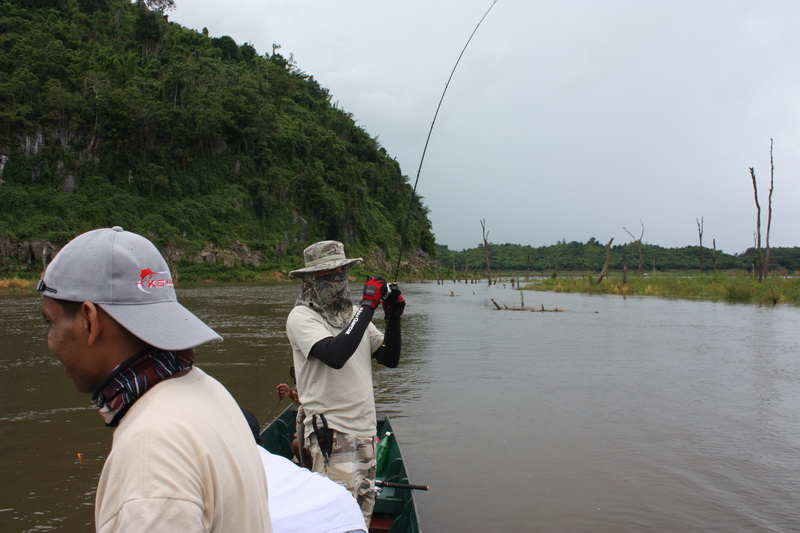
top-left (38, 227), bottom-right (271, 533)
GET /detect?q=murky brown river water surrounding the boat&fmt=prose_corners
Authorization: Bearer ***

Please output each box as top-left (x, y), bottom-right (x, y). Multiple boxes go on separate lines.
top-left (0, 282), bottom-right (800, 532)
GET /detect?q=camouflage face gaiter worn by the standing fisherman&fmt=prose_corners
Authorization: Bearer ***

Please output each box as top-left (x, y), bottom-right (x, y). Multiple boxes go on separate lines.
top-left (295, 272), bottom-right (353, 329)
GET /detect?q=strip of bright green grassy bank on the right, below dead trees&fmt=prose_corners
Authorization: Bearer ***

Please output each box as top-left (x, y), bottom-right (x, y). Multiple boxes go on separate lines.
top-left (525, 275), bottom-right (800, 305)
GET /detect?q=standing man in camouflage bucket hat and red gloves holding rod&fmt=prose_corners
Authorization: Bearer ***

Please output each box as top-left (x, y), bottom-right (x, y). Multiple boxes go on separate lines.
top-left (286, 241), bottom-right (405, 525)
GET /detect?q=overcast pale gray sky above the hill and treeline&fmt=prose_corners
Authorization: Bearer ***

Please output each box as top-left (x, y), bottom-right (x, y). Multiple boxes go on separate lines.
top-left (170, 0), bottom-right (800, 253)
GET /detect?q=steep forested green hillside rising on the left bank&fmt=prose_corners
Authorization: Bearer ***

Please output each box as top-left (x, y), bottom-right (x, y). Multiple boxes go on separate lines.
top-left (0, 0), bottom-right (435, 274)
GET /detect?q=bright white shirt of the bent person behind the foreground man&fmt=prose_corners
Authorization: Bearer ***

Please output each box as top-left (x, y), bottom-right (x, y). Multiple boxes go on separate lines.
top-left (258, 446), bottom-right (367, 533)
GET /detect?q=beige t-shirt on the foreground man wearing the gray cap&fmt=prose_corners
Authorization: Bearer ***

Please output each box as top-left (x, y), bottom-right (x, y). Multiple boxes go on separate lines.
top-left (95, 367), bottom-right (272, 533)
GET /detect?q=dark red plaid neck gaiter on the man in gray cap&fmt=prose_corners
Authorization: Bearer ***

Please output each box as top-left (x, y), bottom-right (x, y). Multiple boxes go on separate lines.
top-left (92, 347), bottom-right (197, 427)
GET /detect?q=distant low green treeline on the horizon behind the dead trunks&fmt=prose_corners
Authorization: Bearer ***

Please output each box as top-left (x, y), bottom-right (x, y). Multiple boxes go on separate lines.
top-left (436, 238), bottom-right (800, 273)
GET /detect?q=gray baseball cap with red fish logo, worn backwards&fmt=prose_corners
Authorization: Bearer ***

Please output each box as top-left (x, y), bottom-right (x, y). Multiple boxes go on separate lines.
top-left (38, 226), bottom-right (222, 351)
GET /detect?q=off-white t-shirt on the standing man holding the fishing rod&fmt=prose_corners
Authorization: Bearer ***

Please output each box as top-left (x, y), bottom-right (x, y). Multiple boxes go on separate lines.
top-left (286, 305), bottom-right (383, 437)
